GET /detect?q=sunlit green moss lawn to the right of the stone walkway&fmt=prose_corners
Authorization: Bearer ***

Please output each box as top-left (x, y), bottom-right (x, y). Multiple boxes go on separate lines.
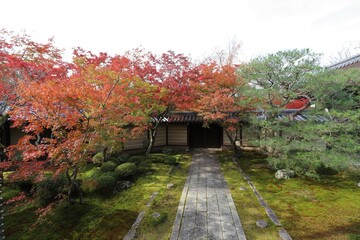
top-left (218, 151), bottom-right (360, 240)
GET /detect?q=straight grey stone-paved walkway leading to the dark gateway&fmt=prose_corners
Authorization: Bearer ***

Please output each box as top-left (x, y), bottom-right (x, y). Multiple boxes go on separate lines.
top-left (170, 150), bottom-right (246, 240)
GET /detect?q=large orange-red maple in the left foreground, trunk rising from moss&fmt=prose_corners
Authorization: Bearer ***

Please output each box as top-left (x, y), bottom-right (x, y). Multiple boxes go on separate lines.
top-left (4, 49), bottom-right (158, 204)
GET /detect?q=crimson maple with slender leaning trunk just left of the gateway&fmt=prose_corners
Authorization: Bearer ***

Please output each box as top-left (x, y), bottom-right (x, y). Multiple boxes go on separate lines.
top-left (129, 49), bottom-right (199, 154)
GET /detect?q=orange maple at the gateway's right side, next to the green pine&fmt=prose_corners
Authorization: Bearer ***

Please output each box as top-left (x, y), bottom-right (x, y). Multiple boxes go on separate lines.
top-left (192, 62), bottom-right (249, 154)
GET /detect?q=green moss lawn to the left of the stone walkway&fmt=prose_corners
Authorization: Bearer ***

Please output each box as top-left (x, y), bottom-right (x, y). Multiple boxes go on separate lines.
top-left (4, 155), bottom-right (191, 240)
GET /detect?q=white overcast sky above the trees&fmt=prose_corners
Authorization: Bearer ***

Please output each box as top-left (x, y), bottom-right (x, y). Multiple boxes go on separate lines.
top-left (0, 0), bottom-right (360, 64)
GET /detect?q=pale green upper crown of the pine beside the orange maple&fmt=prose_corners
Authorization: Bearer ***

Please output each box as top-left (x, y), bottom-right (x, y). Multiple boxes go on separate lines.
top-left (239, 49), bottom-right (321, 110)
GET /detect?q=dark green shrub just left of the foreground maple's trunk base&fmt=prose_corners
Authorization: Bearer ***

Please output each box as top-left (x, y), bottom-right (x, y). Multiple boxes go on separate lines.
top-left (35, 177), bottom-right (66, 206)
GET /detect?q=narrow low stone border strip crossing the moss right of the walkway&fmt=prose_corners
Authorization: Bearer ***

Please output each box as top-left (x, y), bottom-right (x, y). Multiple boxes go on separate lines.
top-left (232, 157), bottom-right (292, 240)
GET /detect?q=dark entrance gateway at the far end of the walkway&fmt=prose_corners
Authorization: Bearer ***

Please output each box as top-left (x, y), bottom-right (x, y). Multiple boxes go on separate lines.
top-left (188, 124), bottom-right (223, 148)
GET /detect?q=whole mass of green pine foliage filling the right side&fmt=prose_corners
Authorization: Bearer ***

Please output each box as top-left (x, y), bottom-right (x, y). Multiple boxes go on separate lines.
top-left (240, 50), bottom-right (360, 178)
